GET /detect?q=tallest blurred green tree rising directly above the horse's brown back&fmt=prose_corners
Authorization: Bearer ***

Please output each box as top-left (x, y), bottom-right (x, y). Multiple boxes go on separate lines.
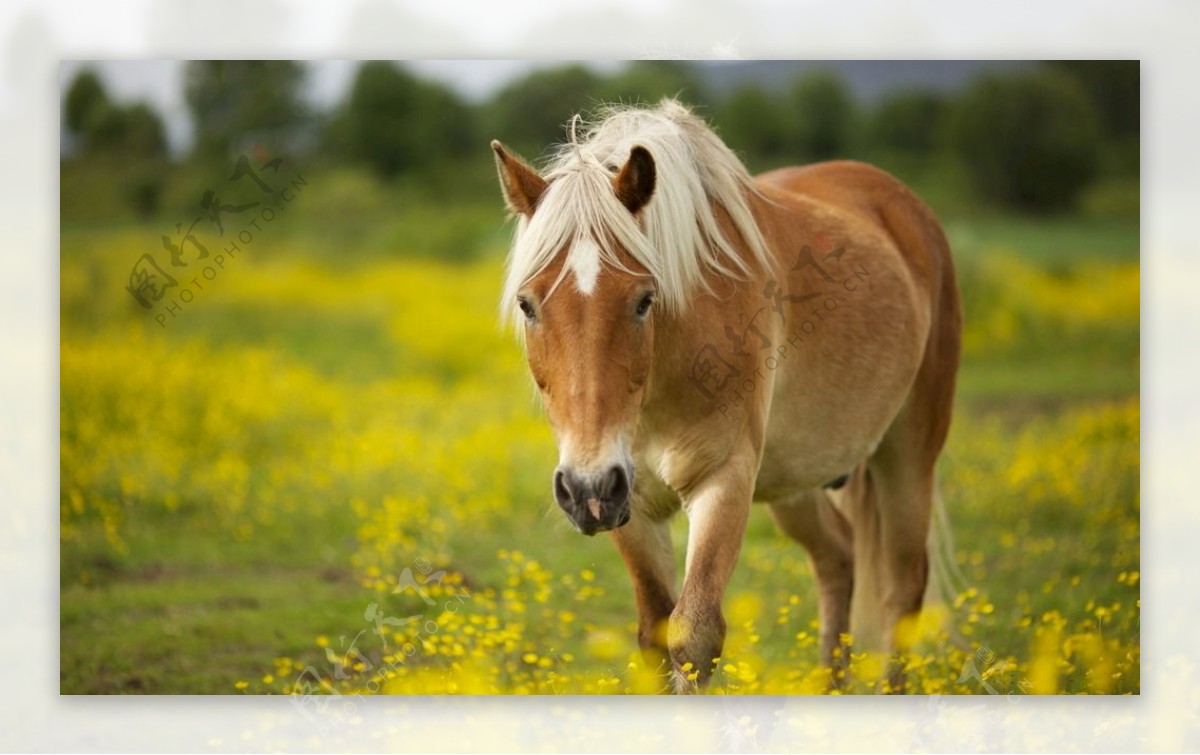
top-left (791, 71), bottom-right (856, 160)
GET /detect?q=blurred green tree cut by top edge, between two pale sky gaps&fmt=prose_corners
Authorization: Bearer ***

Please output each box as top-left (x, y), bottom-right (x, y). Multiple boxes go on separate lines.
top-left (184, 60), bottom-right (308, 158)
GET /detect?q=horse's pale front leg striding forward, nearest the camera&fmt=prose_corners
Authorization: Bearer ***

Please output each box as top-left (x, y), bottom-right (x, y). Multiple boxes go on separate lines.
top-left (667, 463), bottom-right (754, 693)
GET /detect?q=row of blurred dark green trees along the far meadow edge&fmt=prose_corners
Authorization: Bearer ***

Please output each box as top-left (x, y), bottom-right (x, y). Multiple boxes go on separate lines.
top-left (62, 61), bottom-right (1140, 215)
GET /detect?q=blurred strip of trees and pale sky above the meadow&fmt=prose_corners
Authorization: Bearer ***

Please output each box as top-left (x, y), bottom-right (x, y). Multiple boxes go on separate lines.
top-left (60, 60), bottom-right (1140, 232)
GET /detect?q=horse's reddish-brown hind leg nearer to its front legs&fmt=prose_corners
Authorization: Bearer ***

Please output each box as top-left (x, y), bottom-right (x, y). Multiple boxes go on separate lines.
top-left (770, 490), bottom-right (854, 685)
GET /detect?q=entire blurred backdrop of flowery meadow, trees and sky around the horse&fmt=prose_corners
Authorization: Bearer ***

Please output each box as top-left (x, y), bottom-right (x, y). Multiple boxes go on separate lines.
top-left (59, 60), bottom-right (1141, 693)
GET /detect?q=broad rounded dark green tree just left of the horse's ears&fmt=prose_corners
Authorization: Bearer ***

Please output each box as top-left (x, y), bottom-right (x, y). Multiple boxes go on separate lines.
top-left (328, 61), bottom-right (478, 178)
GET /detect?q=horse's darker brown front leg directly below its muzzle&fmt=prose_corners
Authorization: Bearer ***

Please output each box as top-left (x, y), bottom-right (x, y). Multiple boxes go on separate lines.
top-left (612, 507), bottom-right (676, 673)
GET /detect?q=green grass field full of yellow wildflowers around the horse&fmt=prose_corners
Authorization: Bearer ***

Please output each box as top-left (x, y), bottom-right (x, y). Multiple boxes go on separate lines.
top-left (60, 174), bottom-right (1140, 694)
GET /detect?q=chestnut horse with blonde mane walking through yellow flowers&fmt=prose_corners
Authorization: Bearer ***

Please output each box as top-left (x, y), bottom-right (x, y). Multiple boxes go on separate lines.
top-left (492, 100), bottom-right (961, 691)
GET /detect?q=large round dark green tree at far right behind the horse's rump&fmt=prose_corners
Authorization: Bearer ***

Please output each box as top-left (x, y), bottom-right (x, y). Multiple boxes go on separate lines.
top-left (952, 68), bottom-right (1100, 210)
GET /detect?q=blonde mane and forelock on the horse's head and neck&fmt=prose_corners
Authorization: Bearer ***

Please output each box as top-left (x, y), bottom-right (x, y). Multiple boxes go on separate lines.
top-left (500, 100), bottom-right (768, 319)
